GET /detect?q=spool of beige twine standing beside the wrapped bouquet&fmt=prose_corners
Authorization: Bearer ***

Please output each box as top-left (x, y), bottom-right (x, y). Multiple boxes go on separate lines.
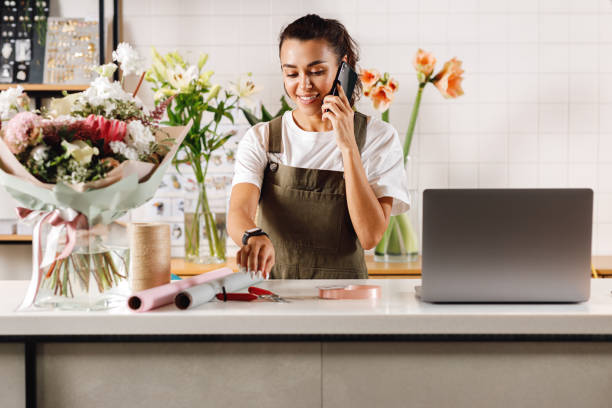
top-left (129, 223), bottom-right (170, 292)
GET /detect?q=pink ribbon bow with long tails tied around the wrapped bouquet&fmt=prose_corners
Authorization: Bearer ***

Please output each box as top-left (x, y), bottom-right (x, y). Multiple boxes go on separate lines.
top-left (17, 207), bottom-right (87, 310)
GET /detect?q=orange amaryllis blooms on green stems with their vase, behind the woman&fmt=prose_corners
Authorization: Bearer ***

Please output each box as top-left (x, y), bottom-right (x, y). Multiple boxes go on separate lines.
top-left (360, 49), bottom-right (463, 262)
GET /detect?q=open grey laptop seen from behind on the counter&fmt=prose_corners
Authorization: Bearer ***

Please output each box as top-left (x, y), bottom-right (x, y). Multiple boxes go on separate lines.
top-left (417, 189), bottom-right (593, 302)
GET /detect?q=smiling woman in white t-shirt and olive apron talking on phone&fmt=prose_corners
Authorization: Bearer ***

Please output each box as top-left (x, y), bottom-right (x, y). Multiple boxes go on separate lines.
top-left (228, 15), bottom-right (408, 279)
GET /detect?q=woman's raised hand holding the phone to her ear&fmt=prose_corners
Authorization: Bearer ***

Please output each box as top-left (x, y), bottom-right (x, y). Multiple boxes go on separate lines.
top-left (321, 86), bottom-right (357, 153)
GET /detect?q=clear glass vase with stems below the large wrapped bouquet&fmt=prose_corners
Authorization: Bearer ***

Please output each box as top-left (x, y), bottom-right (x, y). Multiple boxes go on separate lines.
top-left (34, 225), bottom-right (130, 310)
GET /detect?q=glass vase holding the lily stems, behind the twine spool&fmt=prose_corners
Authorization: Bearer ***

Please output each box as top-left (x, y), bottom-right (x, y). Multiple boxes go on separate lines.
top-left (184, 183), bottom-right (227, 264)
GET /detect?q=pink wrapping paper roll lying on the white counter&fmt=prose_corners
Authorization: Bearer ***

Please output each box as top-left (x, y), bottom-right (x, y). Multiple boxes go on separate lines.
top-left (128, 268), bottom-right (233, 312)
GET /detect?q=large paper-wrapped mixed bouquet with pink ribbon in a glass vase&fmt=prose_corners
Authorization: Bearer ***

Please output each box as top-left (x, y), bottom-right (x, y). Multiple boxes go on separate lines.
top-left (0, 43), bottom-right (188, 310)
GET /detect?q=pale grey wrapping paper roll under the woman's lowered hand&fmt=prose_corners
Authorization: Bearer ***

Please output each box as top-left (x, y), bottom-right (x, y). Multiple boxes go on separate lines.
top-left (174, 272), bottom-right (263, 310)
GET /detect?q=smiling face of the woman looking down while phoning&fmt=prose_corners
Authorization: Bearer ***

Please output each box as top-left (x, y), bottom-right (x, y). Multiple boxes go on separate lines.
top-left (280, 38), bottom-right (338, 116)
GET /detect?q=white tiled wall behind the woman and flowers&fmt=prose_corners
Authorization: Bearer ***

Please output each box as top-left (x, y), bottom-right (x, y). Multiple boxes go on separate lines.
top-left (123, 0), bottom-right (612, 254)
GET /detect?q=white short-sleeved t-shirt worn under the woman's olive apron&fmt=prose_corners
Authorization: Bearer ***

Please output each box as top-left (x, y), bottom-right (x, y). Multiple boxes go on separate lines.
top-left (232, 111), bottom-right (409, 215)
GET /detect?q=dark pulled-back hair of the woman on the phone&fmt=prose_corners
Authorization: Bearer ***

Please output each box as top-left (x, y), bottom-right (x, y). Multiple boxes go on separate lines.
top-left (278, 14), bottom-right (362, 105)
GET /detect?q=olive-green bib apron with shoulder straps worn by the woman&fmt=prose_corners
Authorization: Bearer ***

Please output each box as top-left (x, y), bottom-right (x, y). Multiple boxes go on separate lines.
top-left (258, 112), bottom-right (368, 279)
